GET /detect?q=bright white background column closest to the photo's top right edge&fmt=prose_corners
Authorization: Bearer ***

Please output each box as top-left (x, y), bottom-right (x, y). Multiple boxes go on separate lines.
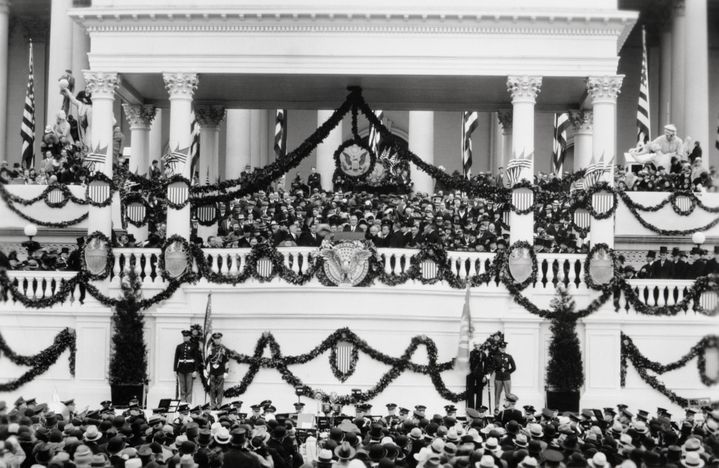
top-left (683, 0), bottom-right (713, 169)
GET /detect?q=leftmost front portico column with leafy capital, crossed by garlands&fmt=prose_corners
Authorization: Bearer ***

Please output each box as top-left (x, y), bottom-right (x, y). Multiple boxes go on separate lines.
top-left (83, 70), bottom-right (119, 237)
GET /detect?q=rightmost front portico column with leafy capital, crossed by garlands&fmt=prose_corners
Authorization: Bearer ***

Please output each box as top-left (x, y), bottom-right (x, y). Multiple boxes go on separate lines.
top-left (587, 75), bottom-right (624, 248)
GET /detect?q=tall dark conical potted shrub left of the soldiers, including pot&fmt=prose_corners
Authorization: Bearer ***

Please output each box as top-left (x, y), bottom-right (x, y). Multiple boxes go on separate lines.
top-left (109, 257), bottom-right (147, 406)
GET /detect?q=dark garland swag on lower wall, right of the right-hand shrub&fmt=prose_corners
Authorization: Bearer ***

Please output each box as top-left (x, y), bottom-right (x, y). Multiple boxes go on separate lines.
top-left (621, 333), bottom-right (719, 407)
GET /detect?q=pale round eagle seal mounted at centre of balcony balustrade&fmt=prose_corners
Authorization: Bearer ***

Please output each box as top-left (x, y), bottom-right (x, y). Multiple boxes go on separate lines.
top-left (320, 241), bottom-right (372, 286)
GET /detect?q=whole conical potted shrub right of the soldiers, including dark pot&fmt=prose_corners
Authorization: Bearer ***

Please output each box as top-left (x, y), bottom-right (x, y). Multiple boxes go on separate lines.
top-left (545, 286), bottom-right (584, 412)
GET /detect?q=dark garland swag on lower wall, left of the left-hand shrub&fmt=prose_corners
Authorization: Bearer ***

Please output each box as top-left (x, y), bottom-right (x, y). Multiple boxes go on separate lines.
top-left (0, 328), bottom-right (76, 392)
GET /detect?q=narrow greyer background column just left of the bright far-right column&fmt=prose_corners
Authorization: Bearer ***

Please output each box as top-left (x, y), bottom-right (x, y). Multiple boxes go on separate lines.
top-left (671, 0), bottom-right (688, 132)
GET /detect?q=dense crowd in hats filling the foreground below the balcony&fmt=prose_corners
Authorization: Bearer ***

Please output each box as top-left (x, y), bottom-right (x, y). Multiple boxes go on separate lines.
top-left (0, 394), bottom-right (719, 468)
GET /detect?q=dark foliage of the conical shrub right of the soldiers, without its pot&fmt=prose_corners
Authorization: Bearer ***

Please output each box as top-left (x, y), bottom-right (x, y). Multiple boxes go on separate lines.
top-left (546, 286), bottom-right (584, 391)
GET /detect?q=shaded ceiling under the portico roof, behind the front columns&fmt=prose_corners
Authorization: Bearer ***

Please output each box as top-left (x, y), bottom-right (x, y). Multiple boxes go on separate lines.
top-left (121, 73), bottom-right (586, 111)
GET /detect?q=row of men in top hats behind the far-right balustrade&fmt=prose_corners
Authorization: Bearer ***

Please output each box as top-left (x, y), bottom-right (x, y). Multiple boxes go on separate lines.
top-left (617, 245), bottom-right (719, 279)
